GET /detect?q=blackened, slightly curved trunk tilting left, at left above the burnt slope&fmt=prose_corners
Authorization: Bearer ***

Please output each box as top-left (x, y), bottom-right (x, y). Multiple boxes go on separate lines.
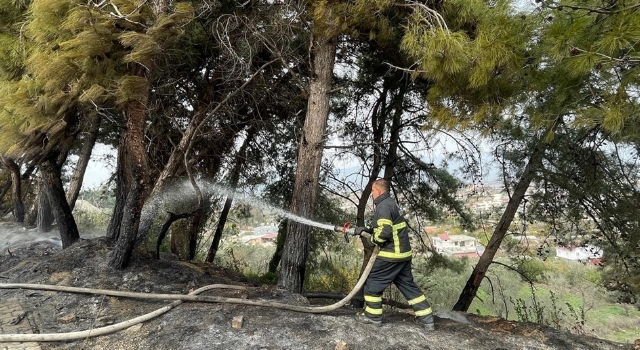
top-left (40, 154), bottom-right (80, 248)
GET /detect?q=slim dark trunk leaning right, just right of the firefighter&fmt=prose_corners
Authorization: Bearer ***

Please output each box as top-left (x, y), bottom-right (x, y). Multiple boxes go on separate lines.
top-left (453, 142), bottom-right (545, 312)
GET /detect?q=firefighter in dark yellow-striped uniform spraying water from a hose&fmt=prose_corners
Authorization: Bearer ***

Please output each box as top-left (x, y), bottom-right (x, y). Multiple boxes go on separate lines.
top-left (353, 179), bottom-right (435, 331)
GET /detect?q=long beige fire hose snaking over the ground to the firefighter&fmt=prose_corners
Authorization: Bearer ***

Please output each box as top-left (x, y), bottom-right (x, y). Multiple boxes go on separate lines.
top-left (0, 227), bottom-right (379, 342)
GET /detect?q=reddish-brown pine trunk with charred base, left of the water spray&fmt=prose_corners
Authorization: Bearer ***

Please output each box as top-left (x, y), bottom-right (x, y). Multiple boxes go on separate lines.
top-left (109, 64), bottom-right (150, 269)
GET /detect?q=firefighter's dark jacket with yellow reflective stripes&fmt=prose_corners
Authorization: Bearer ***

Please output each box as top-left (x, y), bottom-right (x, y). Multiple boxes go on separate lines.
top-left (371, 192), bottom-right (411, 261)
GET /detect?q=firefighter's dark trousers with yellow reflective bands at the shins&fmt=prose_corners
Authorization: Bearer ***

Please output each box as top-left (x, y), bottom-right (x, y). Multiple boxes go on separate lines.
top-left (364, 259), bottom-right (433, 322)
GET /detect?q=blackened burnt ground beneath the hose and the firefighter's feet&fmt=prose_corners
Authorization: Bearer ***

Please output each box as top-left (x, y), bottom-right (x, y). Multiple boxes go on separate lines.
top-left (0, 231), bottom-right (634, 350)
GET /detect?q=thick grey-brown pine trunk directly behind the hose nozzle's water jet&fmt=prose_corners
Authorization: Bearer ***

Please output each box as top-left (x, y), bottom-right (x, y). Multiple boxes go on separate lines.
top-left (278, 37), bottom-right (336, 293)
